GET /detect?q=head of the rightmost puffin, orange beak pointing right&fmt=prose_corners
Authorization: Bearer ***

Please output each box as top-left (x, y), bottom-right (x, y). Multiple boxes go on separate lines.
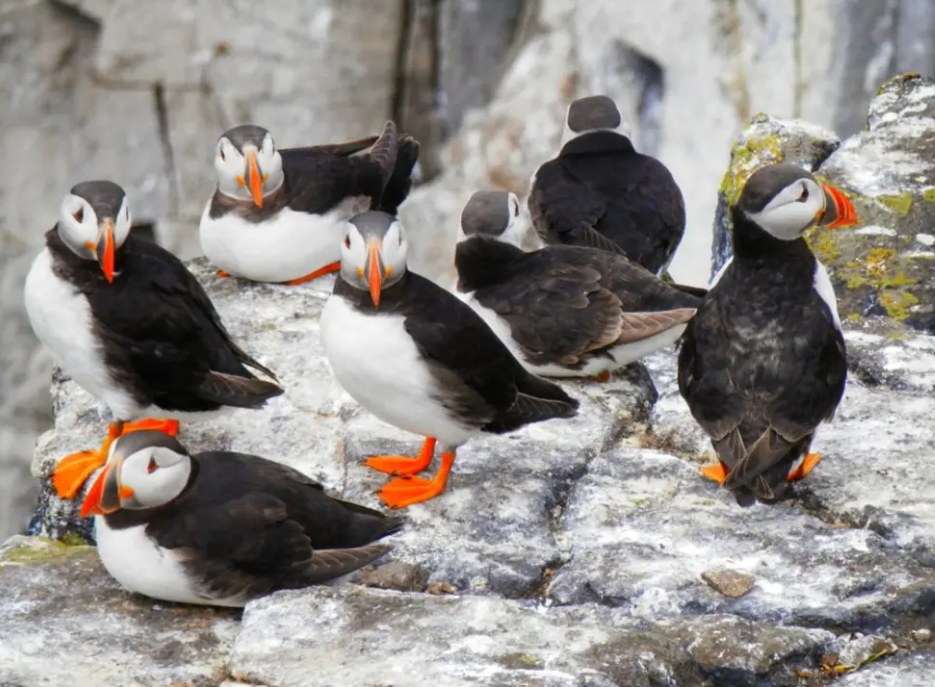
top-left (736, 162), bottom-right (857, 241)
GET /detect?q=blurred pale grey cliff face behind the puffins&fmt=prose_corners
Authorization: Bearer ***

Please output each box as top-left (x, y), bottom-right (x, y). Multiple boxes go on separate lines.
top-left (0, 0), bottom-right (935, 536)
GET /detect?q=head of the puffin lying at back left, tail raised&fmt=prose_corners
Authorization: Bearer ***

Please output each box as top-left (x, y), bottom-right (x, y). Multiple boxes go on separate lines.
top-left (214, 124), bottom-right (285, 208)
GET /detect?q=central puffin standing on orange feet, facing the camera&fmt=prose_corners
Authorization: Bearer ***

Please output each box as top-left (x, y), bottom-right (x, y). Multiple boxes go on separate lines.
top-left (320, 211), bottom-right (578, 508)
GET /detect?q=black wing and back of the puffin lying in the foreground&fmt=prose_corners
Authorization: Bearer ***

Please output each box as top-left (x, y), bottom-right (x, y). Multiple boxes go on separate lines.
top-left (146, 452), bottom-right (402, 596)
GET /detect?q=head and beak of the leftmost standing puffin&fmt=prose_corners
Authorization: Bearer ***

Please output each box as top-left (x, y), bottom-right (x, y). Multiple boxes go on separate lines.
top-left (56, 181), bottom-right (130, 282)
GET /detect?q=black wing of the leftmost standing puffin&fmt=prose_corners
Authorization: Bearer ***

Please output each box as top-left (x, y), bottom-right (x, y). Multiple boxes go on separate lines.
top-left (86, 234), bottom-right (282, 411)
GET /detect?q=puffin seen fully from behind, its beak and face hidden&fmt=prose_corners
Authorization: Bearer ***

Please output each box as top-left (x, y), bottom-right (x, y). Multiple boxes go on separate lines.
top-left (528, 95), bottom-right (685, 274)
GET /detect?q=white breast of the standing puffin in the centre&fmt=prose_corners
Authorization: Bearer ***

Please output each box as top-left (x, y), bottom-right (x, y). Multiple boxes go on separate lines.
top-left (321, 295), bottom-right (478, 447)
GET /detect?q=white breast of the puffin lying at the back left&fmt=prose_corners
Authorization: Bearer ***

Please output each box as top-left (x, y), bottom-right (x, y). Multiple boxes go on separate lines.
top-left (199, 197), bottom-right (370, 283)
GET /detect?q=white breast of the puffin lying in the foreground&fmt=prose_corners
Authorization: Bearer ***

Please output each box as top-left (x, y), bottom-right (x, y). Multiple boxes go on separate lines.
top-left (94, 515), bottom-right (244, 606)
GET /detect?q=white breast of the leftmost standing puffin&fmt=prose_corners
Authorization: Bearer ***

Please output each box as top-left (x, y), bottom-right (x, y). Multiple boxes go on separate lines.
top-left (24, 248), bottom-right (140, 419)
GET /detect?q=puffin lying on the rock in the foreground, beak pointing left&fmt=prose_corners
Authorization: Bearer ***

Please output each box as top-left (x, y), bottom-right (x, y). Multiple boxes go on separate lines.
top-left (81, 430), bottom-right (403, 607)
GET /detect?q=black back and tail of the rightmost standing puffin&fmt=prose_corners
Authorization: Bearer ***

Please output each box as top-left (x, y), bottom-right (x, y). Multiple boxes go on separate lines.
top-left (678, 220), bottom-right (847, 505)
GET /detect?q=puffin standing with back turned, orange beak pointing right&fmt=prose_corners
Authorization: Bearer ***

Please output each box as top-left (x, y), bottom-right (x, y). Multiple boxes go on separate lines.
top-left (678, 163), bottom-right (858, 506)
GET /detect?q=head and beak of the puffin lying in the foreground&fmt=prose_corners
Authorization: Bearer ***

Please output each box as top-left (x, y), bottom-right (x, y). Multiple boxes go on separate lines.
top-left (81, 429), bottom-right (192, 518)
